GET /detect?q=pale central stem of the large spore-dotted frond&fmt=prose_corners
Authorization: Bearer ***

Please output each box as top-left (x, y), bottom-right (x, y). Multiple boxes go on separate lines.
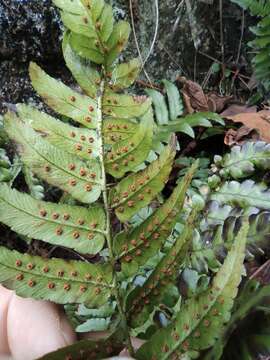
top-left (97, 82), bottom-right (134, 356)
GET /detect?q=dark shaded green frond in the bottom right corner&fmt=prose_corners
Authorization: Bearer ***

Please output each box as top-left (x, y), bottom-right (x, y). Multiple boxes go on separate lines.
top-left (204, 280), bottom-right (270, 360)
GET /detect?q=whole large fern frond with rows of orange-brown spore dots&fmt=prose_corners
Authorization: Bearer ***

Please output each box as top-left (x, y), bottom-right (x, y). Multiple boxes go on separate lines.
top-left (0, 0), bottom-right (247, 360)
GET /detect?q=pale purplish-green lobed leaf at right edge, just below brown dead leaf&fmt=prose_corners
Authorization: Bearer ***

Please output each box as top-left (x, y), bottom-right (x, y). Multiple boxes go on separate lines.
top-left (215, 141), bottom-right (270, 179)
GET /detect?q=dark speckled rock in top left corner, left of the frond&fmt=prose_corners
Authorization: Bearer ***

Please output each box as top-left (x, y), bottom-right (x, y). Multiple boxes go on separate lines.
top-left (0, 0), bottom-right (63, 112)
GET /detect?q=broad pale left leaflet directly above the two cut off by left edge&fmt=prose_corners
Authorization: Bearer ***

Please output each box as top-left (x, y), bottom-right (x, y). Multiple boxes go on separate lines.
top-left (5, 113), bottom-right (101, 203)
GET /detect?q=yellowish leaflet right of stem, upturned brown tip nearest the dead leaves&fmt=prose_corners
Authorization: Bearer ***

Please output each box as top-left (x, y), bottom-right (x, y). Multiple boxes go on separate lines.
top-left (110, 137), bottom-right (175, 222)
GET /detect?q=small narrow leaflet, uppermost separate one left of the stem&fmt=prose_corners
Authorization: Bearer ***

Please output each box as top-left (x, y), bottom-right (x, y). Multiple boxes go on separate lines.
top-left (62, 33), bottom-right (101, 99)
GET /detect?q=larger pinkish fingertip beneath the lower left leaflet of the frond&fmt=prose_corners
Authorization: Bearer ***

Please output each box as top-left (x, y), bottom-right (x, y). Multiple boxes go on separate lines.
top-left (7, 295), bottom-right (76, 360)
